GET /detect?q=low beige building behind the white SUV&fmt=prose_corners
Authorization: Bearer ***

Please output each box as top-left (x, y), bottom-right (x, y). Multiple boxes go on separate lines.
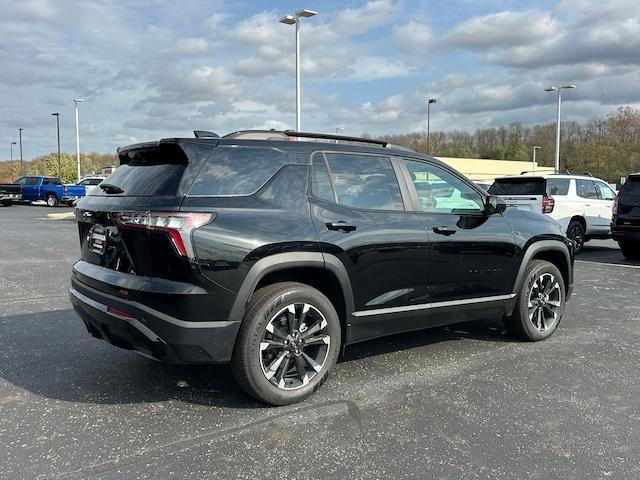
top-left (436, 157), bottom-right (553, 181)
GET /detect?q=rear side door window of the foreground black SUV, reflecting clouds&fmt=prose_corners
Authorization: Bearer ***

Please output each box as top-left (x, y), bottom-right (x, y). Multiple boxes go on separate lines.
top-left (312, 152), bottom-right (404, 210)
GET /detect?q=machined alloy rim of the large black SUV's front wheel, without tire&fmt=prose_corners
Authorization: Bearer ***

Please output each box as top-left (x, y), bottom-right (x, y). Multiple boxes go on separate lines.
top-left (527, 273), bottom-right (562, 332)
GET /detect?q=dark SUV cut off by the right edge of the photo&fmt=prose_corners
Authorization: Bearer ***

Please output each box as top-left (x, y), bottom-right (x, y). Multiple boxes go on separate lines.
top-left (611, 173), bottom-right (640, 260)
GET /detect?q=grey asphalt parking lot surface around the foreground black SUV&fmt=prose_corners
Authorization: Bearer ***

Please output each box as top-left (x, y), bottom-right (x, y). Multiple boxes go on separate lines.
top-left (0, 206), bottom-right (640, 479)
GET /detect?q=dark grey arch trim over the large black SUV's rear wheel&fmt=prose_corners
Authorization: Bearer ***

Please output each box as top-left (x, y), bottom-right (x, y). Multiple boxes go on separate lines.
top-left (229, 252), bottom-right (353, 344)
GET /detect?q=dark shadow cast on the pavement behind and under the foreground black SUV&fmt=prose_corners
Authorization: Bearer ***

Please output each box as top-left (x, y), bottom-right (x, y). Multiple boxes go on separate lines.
top-left (0, 309), bottom-right (511, 408)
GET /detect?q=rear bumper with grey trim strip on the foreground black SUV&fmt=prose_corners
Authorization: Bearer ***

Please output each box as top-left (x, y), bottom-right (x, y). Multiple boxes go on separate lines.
top-left (70, 279), bottom-right (240, 364)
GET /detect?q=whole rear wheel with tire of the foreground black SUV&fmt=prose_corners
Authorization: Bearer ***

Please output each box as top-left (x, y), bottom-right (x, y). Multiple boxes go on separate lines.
top-left (231, 282), bottom-right (341, 405)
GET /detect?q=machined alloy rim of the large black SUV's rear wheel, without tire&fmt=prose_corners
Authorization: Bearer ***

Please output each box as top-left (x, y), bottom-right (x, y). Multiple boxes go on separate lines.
top-left (259, 303), bottom-right (331, 390)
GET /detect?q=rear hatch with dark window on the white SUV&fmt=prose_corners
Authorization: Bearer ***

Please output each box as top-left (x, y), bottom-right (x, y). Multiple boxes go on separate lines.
top-left (489, 176), bottom-right (548, 213)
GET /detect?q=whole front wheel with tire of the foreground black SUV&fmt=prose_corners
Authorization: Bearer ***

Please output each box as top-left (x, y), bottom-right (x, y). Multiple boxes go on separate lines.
top-left (504, 260), bottom-right (567, 342)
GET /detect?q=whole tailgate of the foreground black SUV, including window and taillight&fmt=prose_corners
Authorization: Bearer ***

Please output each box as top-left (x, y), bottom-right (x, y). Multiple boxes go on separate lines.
top-left (76, 139), bottom-right (216, 289)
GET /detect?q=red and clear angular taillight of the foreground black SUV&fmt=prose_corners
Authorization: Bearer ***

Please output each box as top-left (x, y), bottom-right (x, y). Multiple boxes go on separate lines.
top-left (113, 212), bottom-right (214, 260)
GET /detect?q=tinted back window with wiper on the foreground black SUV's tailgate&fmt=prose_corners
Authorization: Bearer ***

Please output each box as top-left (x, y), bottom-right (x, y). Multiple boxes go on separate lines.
top-left (95, 143), bottom-right (212, 197)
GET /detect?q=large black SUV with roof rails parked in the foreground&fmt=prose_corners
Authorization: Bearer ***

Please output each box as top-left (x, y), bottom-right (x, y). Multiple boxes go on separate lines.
top-left (71, 131), bottom-right (573, 405)
